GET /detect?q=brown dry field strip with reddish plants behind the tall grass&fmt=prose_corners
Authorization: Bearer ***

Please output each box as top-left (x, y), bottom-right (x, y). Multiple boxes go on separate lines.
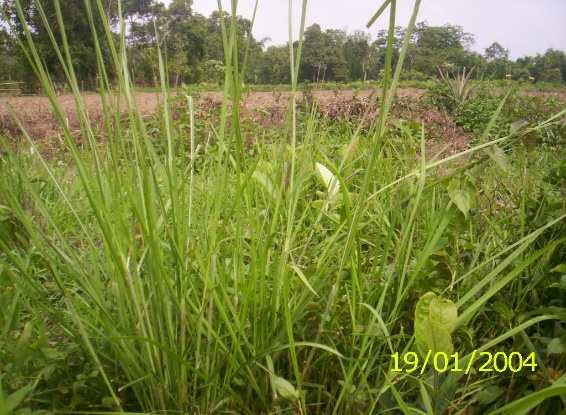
top-left (0, 88), bottom-right (464, 155)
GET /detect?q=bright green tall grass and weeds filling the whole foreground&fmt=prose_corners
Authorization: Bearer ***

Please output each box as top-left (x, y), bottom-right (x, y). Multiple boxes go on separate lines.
top-left (0, 0), bottom-right (566, 414)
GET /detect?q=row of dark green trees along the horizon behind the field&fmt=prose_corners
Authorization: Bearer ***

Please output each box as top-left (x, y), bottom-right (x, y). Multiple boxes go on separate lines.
top-left (0, 0), bottom-right (566, 87)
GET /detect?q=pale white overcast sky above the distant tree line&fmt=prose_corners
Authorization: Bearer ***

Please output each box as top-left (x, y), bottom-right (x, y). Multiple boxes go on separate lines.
top-left (169, 0), bottom-right (566, 58)
